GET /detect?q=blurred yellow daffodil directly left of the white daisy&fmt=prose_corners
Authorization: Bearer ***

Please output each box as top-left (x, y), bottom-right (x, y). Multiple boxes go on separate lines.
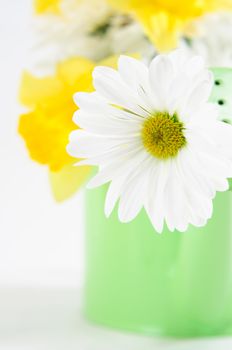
top-left (19, 58), bottom-right (118, 200)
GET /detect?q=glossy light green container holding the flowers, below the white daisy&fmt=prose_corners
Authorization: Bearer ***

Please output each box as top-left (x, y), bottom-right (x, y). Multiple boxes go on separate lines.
top-left (85, 70), bottom-right (232, 337)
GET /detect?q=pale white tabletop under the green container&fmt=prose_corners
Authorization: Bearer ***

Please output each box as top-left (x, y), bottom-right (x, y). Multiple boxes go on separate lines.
top-left (0, 288), bottom-right (232, 350)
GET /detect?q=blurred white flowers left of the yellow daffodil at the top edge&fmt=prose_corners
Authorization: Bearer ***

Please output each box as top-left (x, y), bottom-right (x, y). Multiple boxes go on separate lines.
top-left (28, 0), bottom-right (154, 74)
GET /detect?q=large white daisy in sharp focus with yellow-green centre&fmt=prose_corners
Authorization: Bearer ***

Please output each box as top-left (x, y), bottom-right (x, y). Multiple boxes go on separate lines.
top-left (67, 50), bottom-right (232, 232)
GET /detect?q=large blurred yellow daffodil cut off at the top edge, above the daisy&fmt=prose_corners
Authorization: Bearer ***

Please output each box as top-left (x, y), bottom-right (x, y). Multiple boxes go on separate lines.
top-left (109, 0), bottom-right (232, 51)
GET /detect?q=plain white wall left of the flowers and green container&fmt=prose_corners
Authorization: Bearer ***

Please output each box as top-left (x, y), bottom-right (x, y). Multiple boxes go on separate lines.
top-left (0, 0), bottom-right (83, 286)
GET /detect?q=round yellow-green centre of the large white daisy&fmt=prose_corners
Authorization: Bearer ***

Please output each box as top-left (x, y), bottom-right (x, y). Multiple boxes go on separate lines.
top-left (141, 112), bottom-right (186, 159)
